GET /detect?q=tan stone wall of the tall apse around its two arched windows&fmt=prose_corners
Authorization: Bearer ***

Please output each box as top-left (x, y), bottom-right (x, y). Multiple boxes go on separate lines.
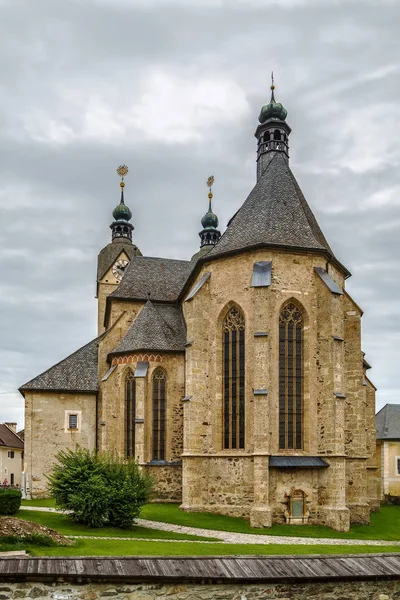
top-left (183, 249), bottom-right (378, 530)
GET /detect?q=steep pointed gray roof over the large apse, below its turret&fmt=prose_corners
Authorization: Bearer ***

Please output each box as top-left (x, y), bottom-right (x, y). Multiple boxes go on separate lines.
top-left (208, 153), bottom-right (332, 258)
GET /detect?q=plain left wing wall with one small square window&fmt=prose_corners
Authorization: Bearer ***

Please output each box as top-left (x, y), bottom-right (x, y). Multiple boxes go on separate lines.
top-left (24, 392), bottom-right (96, 498)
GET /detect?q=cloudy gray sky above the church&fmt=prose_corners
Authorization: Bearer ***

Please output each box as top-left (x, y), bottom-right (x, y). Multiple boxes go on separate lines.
top-left (0, 0), bottom-right (400, 427)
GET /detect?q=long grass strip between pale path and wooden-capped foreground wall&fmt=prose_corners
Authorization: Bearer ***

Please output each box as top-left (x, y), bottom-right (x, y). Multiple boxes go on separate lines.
top-left (27, 539), bottom-right (399, 556)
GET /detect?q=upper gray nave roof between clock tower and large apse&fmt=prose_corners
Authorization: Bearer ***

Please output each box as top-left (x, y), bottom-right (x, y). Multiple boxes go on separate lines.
top-left (109, 256), bottom-right (194, 302)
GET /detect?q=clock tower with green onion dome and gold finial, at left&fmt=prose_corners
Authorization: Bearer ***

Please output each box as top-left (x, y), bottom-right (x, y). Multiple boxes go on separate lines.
top-left (97, 165), bottom-right (142, 335)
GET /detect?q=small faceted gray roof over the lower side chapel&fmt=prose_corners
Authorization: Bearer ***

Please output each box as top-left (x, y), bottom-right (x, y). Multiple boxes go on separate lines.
top-left (111, 301), bottom-right (186, 354)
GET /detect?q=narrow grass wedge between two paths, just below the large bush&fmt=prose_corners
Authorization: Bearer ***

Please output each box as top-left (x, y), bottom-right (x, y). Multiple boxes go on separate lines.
top-left (16, 510), bottom-right (215, 541)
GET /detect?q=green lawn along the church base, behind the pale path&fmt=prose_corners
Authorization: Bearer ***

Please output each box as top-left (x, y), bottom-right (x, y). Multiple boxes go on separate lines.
top-left (20, 499), bottom-right (400, 541)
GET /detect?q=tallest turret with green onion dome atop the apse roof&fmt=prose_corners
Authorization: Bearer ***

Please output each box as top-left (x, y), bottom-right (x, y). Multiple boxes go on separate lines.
top-left (255, 72), bottom-right (291, 179)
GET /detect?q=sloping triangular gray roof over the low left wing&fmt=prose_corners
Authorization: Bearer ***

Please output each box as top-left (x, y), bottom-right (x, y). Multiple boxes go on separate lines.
top-left (19, 334), bottom-right (104, 393)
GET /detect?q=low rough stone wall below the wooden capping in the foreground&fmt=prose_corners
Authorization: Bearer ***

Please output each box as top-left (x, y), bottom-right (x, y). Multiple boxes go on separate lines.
top-left (0, 581), bottom-right (400, 600)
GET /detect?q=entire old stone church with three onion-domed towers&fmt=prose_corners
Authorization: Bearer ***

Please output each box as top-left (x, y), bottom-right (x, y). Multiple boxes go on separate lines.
top-left (20, 85), bottom-right (380, 531)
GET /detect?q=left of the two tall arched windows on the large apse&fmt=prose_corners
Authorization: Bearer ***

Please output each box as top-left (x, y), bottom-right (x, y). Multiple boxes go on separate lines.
top-left (223, 307), bottom-right (245, 449)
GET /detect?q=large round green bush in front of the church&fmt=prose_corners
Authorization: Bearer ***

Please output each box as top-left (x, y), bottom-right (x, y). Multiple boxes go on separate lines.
top-left (48, 448), bottom-right (152, 527)
